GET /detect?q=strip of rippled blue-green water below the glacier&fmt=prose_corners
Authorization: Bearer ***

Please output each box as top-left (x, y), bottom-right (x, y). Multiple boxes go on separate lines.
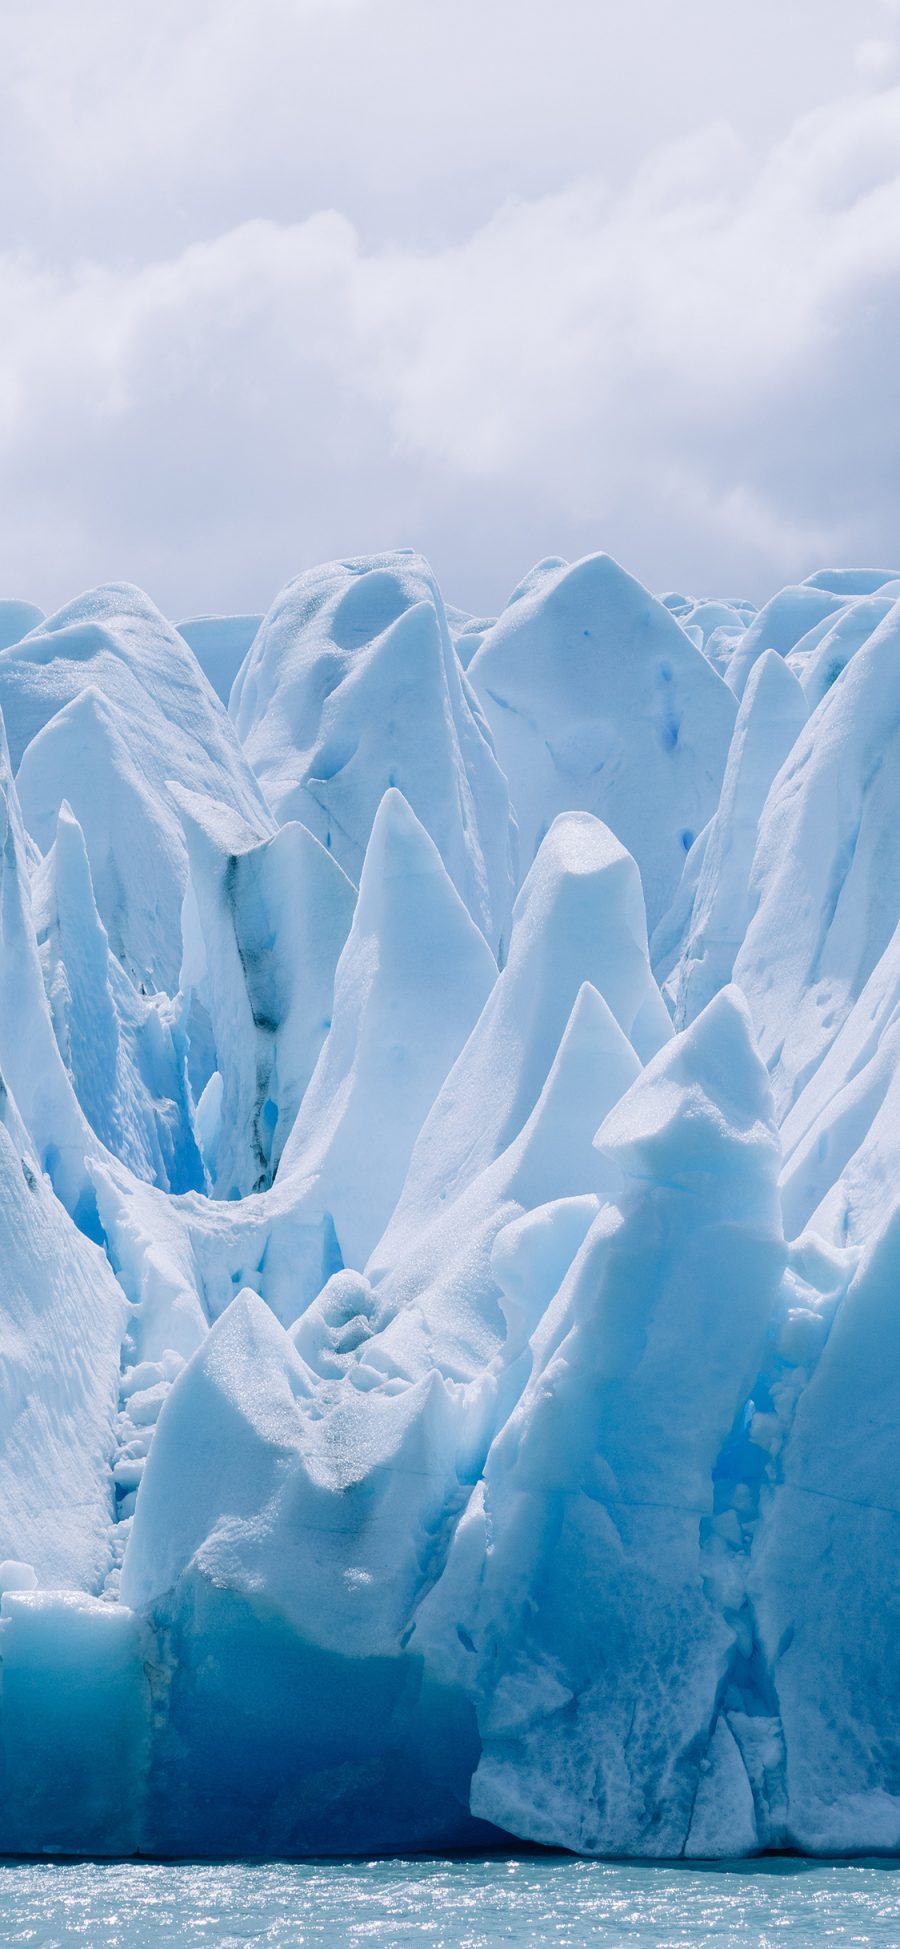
top-left (0, 1855), bottom-right (900, 1949)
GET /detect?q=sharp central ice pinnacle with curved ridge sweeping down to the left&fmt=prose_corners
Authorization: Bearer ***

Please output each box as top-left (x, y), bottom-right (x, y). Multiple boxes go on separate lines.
top-left (97, 791), bottom-right (497, 1345)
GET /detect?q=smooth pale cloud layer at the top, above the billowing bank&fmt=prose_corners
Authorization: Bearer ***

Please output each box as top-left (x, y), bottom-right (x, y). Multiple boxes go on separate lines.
top-left (0, 0), bottom-right (884, 263)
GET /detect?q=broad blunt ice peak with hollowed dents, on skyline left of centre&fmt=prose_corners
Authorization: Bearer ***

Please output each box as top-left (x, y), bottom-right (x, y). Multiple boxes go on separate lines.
top-left (232, 552), bottom-right (514, 947)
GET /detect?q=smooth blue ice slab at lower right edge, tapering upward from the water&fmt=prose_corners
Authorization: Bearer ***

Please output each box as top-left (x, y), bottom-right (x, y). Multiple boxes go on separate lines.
top-left (752, 1179), bottom-right (900, 1855)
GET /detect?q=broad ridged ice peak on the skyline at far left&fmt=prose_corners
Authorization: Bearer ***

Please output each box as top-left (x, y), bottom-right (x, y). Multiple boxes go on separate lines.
top-left (0, 585), bottom-right (273, 994)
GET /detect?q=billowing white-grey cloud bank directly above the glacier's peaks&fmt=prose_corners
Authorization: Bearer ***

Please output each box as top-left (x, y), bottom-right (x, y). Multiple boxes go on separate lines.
top-left (0, 34), bottom-right (900, 612)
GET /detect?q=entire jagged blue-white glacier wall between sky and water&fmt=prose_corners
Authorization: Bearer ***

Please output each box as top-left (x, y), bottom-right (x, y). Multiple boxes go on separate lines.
top-left (0, 550), bottom-right (900, 1859)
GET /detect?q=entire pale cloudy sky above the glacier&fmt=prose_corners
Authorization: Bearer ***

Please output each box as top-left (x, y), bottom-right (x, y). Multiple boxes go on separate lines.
top-left (0, 0), bottom-right (900, 618)
